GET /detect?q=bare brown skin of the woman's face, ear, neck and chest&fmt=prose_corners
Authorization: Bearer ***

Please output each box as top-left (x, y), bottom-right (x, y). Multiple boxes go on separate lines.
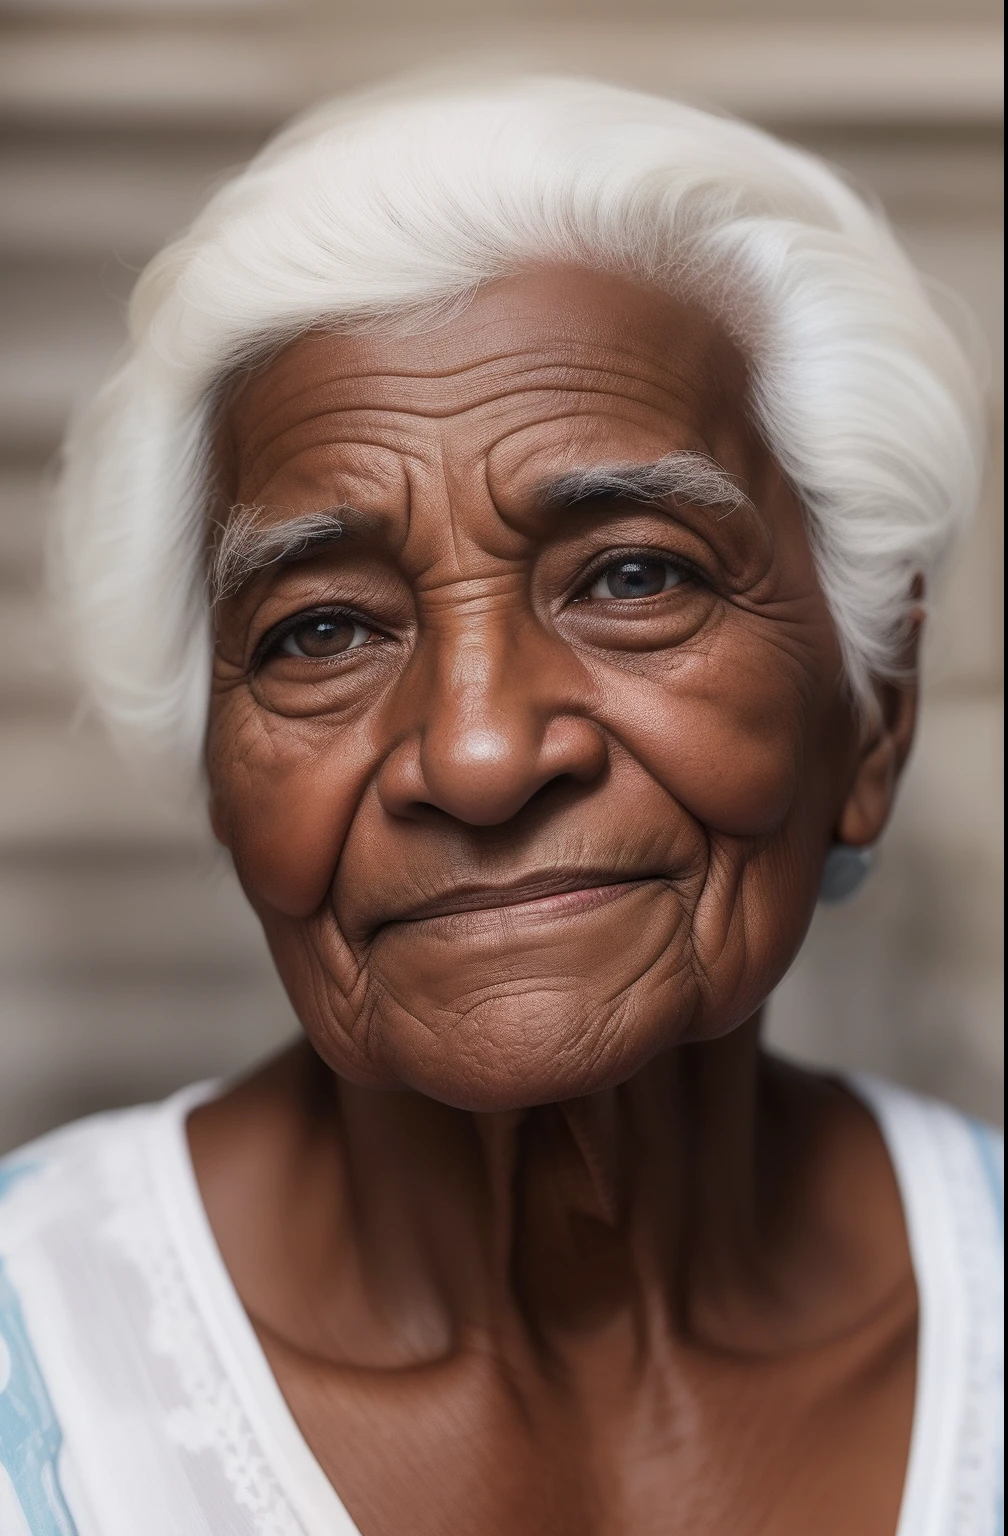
top-left (189, 270), bottom-right (916, 1536)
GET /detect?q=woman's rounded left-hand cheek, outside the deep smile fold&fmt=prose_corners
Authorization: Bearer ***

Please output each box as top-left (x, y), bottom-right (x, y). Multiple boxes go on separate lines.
top-left (207, 699), bottom-right (373, 919)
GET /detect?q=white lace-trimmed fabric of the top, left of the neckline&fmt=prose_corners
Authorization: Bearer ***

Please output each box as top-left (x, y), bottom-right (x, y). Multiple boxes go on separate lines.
top-left (0, 1092), bottom-right (355, 1536)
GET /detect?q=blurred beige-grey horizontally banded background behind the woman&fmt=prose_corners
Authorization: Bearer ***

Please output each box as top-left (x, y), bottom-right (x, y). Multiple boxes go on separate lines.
top-left (0, 0), bottom-right (1003, 1150)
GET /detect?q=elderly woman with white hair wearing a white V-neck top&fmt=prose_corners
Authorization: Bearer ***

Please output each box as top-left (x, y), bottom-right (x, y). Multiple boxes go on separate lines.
top-left (0, 80), bottom-right (1000, 1536)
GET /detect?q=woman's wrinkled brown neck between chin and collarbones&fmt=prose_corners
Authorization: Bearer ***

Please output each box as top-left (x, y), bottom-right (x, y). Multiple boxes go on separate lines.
top-left (191, 1015), bottom-right (835, 1364)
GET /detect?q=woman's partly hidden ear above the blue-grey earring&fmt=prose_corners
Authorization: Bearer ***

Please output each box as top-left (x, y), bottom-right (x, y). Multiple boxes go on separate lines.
top-left (836, 578), bottom-right (923, 848)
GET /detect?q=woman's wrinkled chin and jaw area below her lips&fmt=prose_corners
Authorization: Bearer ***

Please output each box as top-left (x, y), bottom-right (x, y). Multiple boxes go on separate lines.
top-left (272, 888), bottom-right (734, 1112)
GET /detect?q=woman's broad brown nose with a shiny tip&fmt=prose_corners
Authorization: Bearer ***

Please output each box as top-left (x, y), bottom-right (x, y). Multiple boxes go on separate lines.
top-left (378, 619), bottom-right (608, 826)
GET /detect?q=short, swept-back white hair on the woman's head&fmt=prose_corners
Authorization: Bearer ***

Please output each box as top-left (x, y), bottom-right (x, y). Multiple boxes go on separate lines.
top-left (55, 77), bottom-right (982, 783)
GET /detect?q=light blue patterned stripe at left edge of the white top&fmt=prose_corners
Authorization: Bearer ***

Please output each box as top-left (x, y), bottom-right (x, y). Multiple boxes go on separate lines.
top-left (0, 1164), bottom-right (77, 1536)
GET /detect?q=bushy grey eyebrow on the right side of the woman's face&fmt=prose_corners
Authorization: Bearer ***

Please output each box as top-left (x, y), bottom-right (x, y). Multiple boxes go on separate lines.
top-left (539, 452), bottom-right (753, 516)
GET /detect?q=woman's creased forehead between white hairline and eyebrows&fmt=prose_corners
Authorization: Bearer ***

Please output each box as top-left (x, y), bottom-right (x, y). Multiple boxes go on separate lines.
top-left (223, 269), bottom-right (753, 501)
